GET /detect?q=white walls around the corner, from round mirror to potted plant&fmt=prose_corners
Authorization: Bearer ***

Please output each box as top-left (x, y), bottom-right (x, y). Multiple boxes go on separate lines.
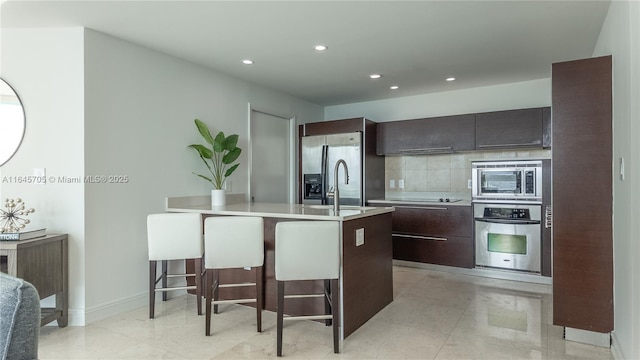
top-left (1, 28), bottom-right (323, 325)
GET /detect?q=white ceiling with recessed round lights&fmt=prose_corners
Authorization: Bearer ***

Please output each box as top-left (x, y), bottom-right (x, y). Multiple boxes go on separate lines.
top-left (0, 0), bottom-right (609, 106)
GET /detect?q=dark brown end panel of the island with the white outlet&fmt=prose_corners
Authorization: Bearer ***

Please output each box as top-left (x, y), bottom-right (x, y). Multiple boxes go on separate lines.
top-left (342, 213), bottom-right (393, 338)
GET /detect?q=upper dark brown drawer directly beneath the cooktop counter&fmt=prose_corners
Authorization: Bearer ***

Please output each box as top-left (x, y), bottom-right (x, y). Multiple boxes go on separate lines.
top-left (393, 205), bottom-right (473, 237)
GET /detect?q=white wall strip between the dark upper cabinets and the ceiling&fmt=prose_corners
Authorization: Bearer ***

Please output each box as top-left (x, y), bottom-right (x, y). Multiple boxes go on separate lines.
top-left (324, 78), bottom-right (551, 122)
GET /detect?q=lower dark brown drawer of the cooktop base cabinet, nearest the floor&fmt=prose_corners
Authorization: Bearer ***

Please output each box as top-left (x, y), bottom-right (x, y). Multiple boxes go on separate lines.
top-left (393, 235), bottom-right (474, 268)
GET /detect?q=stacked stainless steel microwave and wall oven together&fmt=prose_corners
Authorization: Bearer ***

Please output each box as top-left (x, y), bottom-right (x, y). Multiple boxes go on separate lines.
top-left (472, 160), bottom-right (543, 274)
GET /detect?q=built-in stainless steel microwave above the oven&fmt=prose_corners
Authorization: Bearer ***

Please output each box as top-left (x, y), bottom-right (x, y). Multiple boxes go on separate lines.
top-left (471, 160), bottom-right (542, 202)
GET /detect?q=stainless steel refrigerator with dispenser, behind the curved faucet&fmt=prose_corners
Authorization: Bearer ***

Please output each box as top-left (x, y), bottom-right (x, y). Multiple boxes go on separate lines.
top-left (300, 132), bottom-right (364, 205)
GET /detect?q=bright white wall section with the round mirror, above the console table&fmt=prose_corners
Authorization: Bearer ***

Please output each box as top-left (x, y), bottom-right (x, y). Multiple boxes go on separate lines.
top-left (0, 28), bottom-right (85, 317)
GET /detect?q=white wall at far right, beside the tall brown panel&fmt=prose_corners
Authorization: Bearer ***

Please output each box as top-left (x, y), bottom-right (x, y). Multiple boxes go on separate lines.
top-left (593, 1), bottom-right (640, 359)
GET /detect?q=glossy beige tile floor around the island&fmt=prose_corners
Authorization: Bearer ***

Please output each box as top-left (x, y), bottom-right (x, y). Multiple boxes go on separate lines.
top-left (39, 267), bottom-right (613, 360)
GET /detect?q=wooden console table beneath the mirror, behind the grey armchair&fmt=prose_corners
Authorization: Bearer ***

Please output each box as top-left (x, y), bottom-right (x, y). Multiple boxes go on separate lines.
top-left (0, 234), bottom-right (69, 327)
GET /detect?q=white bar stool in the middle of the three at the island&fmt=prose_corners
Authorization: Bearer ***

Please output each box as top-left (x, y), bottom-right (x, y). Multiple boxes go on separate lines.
top-left (204, 216), bottom-right (264, 336)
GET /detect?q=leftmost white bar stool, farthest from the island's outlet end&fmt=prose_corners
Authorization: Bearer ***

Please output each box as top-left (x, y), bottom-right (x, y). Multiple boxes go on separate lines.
top-left (147, 213), bottom-right (204, 319)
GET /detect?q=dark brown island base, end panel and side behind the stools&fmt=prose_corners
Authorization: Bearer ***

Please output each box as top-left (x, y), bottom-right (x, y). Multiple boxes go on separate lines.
top-left (190, 213), bottom-right (393, 338)
